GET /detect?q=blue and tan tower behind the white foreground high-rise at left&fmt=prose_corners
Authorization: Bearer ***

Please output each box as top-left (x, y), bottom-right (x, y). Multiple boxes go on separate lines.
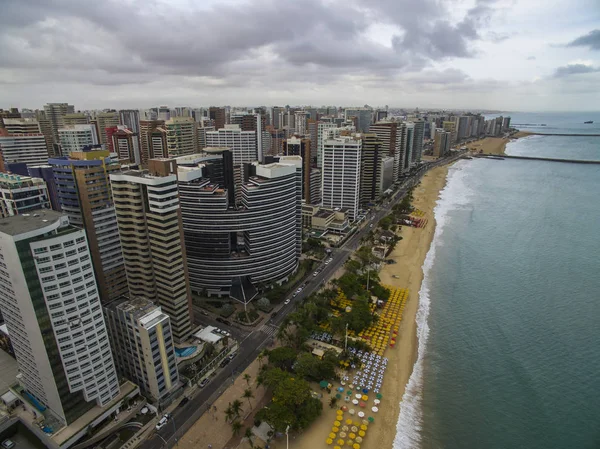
top-left (48, 150), bottom-right (127, 303)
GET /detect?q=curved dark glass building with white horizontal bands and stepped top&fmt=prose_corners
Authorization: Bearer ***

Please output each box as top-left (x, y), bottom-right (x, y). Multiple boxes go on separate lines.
top-left (178, 158), bottom-right (301, 303)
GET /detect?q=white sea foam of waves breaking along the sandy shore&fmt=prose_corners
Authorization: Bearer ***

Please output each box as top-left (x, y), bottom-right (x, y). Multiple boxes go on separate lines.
top-left (393, 161), bottom-right (479, 449)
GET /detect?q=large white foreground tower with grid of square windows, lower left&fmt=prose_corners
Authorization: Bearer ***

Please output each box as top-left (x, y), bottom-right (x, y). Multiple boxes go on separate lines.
top-left (0, 210), bottom-right (119, 424)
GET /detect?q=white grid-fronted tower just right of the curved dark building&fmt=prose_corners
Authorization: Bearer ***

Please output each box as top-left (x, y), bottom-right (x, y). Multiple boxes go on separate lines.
top-left (322, 136), bottom-right (362, 220)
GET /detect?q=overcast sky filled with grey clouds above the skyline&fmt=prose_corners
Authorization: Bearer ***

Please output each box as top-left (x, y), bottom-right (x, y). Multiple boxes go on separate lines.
top-left (0, 0), bottom-right (600, 111)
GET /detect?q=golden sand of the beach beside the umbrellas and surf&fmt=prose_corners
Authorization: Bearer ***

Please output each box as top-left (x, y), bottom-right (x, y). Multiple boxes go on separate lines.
top-left (290, 166), bottom-right (448, 449)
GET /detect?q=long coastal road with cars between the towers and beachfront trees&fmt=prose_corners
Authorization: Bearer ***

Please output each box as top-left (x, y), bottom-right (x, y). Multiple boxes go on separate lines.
top-left (140, 153), bottom-right (454, 449)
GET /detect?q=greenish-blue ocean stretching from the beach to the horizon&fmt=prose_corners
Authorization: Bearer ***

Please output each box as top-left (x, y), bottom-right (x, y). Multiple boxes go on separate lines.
top-left (394, 113), bottom-right (600, 449)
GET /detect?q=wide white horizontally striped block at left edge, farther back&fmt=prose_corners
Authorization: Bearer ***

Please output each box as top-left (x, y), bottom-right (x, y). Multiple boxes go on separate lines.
top-left (0, 128), bottom-right (48, 171)
